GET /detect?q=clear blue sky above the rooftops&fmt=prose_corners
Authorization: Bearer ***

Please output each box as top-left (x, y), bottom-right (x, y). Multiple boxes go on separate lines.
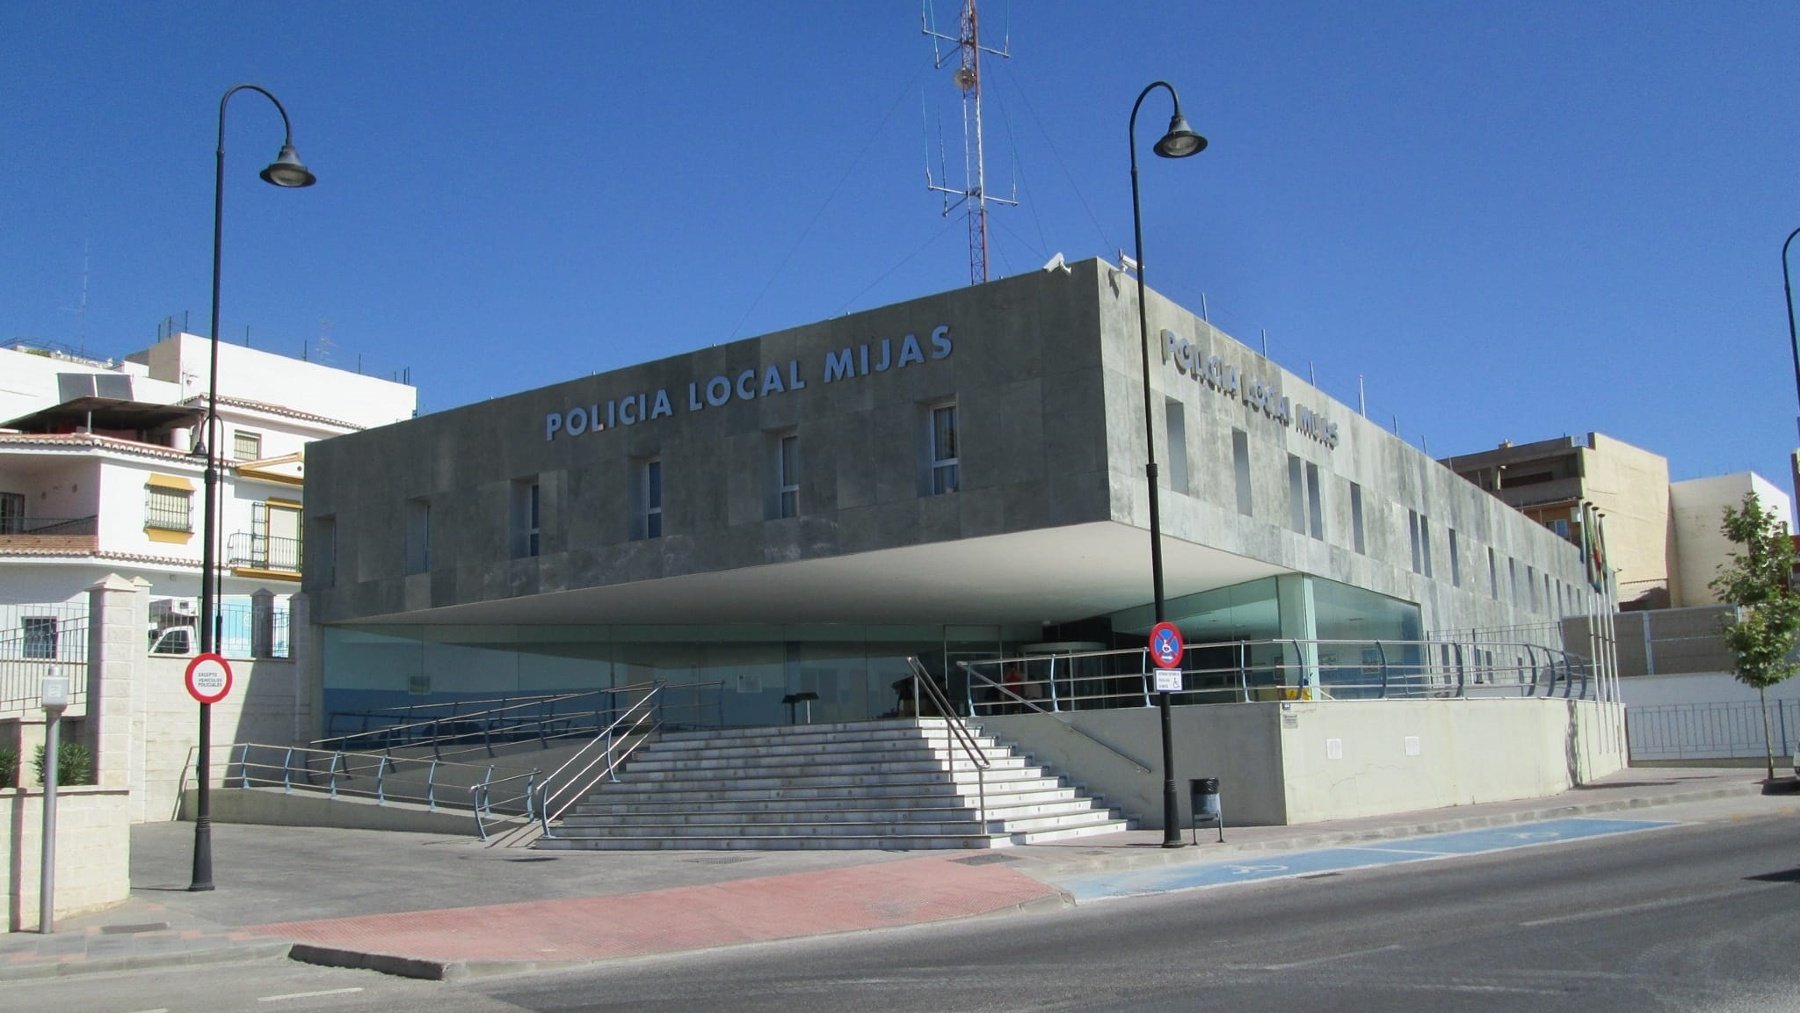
top-left (0, 0), bottom-right (1800, 488)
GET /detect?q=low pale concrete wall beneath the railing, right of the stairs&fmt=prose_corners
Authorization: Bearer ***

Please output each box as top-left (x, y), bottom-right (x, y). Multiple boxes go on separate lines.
top-left (981, 698), bottom-right (1625, 828)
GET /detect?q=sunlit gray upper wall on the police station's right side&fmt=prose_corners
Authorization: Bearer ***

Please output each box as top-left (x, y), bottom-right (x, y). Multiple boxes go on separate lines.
top-left (1100, 266), bottom-right (1588, 632)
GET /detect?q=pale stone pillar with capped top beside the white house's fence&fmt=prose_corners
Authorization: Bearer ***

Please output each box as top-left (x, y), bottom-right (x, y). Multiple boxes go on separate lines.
top-left (85, 574), bottom-right (149, 788)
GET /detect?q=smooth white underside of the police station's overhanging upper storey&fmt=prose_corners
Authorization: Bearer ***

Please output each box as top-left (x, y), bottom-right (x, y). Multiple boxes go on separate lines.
top-left (343, 522), bottom-right (1285, 626)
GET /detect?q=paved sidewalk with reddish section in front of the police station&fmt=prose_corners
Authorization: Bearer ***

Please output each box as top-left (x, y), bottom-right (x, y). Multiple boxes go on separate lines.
top-left (0, 768), bottom-right (1785, 981)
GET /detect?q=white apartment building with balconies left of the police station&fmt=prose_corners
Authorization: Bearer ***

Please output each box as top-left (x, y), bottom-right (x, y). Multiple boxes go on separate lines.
top-left (0, 333), bottom-right (418, 641)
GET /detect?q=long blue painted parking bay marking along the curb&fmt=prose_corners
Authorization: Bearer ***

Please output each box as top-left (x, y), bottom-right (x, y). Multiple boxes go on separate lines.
top-left (1062, 817), bottom-right (1676, 900)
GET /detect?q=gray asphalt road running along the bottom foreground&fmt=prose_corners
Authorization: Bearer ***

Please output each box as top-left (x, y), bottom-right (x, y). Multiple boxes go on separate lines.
top-left (14, 811), bottom-right (1800, 1013)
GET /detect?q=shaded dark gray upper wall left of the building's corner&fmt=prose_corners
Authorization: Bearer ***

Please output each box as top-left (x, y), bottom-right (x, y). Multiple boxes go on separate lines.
top-left (306, 264), bottom-right (1109, 623)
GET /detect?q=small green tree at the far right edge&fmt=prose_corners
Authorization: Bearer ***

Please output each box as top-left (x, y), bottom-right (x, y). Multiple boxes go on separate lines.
top-left (1712, 493), bottom-right (1800, 777)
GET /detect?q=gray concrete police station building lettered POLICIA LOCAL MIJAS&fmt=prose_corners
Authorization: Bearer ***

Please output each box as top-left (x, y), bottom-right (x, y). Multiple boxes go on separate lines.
top-left (304, 261), bottom-right (1622, 822)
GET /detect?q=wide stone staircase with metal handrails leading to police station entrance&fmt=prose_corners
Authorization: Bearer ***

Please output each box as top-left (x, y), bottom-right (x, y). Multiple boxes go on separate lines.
top-left (535, 718), bottom-right (1129, 851)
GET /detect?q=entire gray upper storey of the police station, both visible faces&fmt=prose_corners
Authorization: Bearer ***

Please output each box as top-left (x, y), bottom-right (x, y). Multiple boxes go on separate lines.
top-left (306, 261), bottom-right (1582, 630)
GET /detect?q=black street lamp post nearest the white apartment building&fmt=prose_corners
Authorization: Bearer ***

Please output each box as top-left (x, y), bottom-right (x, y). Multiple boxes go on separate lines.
top-left (187, 85), bottom-right (317, 891)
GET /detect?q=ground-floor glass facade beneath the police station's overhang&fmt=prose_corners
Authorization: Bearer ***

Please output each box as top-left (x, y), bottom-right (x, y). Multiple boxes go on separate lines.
top-left (324, 574), bottom-right (1420, 736)
